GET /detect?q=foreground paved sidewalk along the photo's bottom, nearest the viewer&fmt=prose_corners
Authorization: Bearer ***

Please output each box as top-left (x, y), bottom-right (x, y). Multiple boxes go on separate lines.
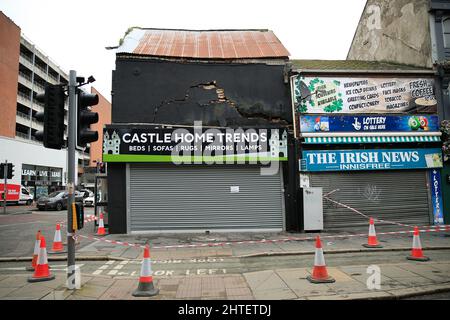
top-left (0, 261), bottom-right (450, 300)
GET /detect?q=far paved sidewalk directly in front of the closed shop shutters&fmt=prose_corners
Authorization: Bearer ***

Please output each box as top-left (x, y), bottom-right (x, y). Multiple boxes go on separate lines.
top-left (66, 227), bottom-right (450, 260)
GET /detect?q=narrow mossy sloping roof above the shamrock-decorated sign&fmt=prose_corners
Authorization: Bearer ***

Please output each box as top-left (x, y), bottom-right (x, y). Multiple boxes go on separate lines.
top-left (290, 60), bottom-right (431, 71)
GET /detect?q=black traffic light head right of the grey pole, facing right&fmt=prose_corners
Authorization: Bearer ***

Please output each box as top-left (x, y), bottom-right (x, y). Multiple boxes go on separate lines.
top-left (76, 90), bottom-right (98, 148)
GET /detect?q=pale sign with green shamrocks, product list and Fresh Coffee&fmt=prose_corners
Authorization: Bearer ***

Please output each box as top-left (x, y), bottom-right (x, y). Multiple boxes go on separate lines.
top-left (292, 75), bottom-right (437, 113)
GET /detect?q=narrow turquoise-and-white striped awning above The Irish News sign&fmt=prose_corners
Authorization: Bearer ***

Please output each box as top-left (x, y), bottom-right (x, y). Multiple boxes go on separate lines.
top-left (304, 136), bottom-right (441, 144)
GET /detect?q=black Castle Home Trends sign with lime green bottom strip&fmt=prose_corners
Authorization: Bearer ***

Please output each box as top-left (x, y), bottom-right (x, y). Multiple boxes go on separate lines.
top-left (103, 127), bottom-right (287, 164)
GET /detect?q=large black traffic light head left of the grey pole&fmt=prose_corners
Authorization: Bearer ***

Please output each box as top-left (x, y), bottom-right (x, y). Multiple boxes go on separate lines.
top-left (34, 85), bottom-right (66, 150)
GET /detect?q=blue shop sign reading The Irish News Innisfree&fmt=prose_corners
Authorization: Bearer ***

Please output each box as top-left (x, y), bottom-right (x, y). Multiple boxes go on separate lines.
top-left (300, 148), bottom-right (442, 171)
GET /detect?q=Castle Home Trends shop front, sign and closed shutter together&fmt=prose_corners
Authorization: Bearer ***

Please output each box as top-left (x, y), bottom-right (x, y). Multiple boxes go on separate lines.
top-left (103, 125), bottom-right (287, 233)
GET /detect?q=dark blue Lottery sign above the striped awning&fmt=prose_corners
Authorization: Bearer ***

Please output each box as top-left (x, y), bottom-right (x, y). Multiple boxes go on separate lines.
top-left (298, 115), bottom-right (439, 133)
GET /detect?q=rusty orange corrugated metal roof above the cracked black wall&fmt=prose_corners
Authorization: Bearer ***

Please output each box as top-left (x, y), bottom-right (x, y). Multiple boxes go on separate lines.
top-left (117, 28), bottom-right (289, 59)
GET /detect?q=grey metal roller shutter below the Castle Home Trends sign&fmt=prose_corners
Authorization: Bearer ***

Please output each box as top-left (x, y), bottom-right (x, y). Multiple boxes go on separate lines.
top-left (129, 164), bottom-right (283, 232)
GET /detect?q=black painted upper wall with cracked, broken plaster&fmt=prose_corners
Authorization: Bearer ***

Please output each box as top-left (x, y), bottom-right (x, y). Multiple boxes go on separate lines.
top-left (112, 57), bottom-right (292, 127)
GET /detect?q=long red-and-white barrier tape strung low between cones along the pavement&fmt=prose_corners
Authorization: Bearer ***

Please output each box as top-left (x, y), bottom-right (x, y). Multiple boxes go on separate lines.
top-left (74, 225), bottom-right (450, 249)
